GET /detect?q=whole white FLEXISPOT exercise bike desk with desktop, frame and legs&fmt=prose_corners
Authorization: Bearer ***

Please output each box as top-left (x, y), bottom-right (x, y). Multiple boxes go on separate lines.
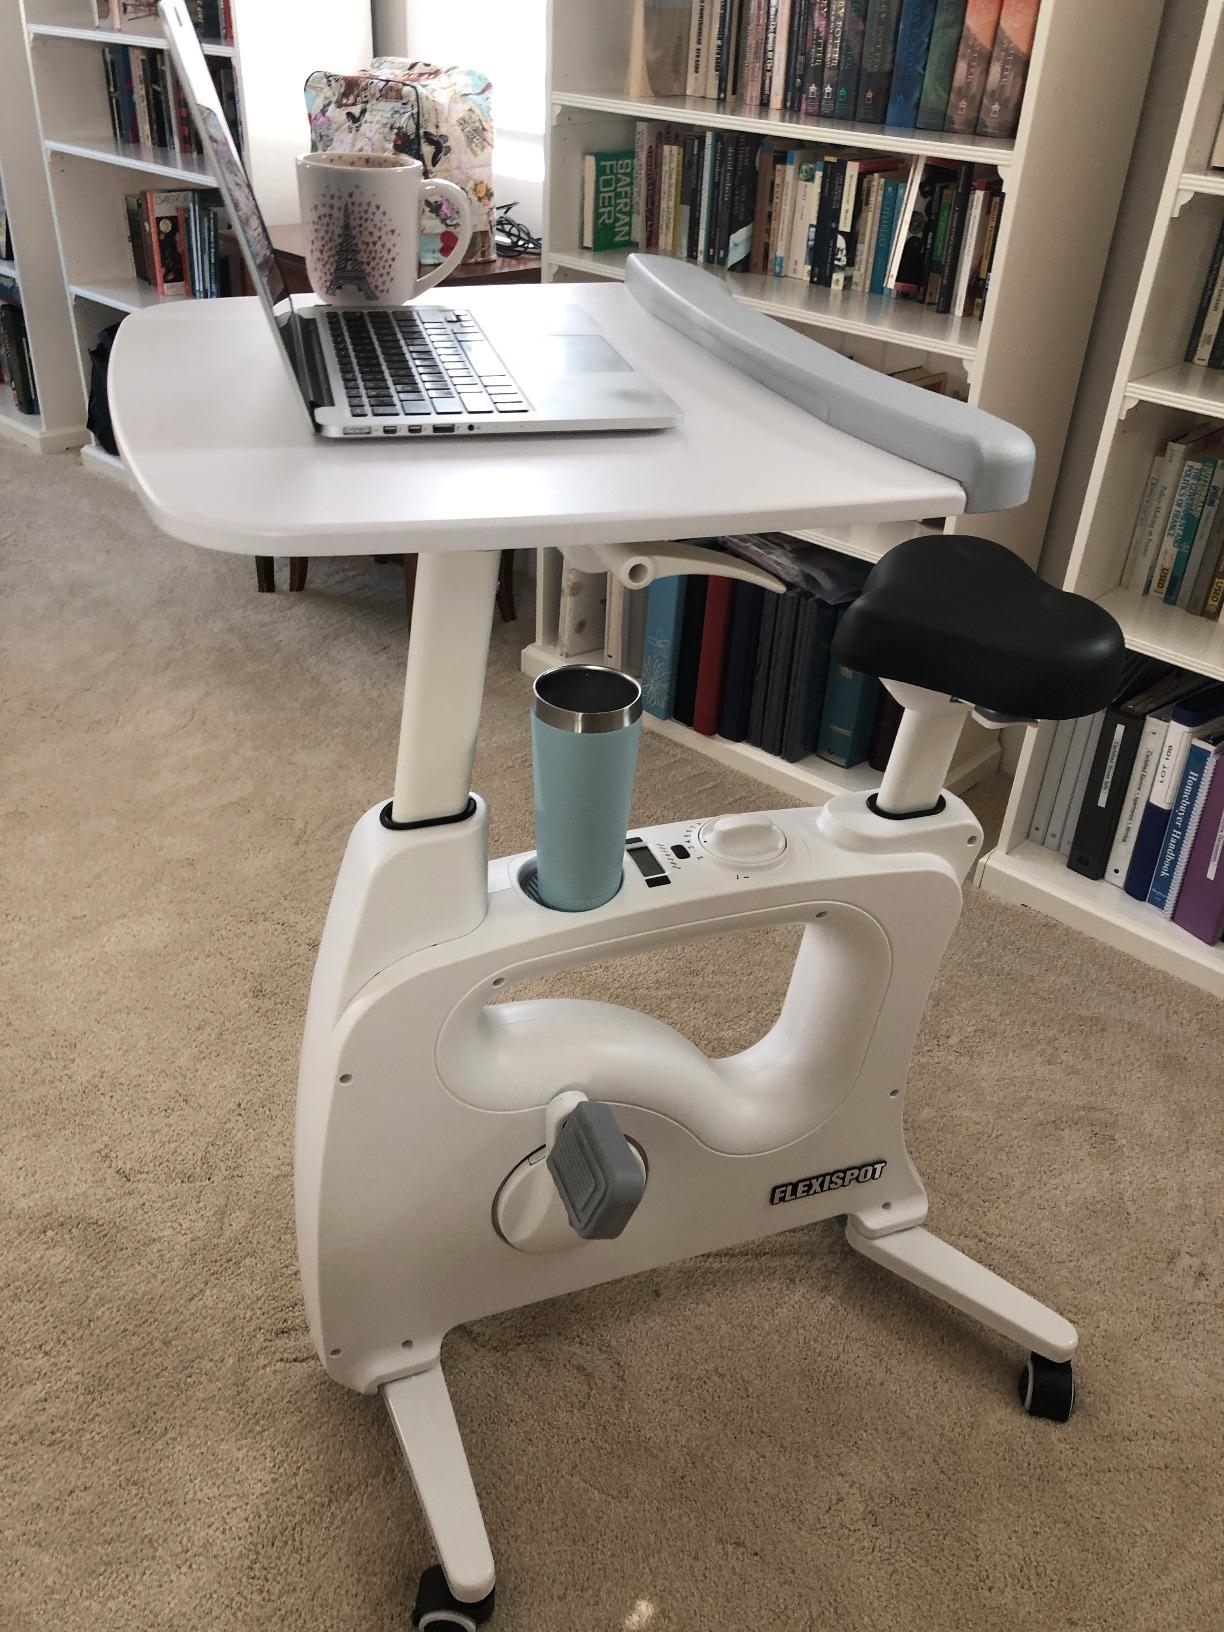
top-left (109, 274), bottom-right (1103, 1627)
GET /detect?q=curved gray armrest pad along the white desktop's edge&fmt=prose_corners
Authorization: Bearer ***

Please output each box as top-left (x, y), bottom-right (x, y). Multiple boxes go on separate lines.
top-left (625, 255), bottom-right (1036, 514)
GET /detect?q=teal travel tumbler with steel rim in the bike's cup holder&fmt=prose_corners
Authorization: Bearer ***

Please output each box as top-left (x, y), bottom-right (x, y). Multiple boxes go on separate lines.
top-left (532, 666), bottom-right (641, 912)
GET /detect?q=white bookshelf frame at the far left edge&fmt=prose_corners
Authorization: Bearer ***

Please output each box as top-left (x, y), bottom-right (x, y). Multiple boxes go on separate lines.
top-left (0, 0), bottom-right (85, 452)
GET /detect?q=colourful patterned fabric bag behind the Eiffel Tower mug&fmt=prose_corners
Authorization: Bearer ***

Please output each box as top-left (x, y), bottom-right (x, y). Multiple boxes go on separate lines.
top-left (305, 57), bottom-right (498, 266)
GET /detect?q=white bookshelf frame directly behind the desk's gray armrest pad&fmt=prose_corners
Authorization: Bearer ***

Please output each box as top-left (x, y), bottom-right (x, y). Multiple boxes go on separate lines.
top-left (526, 0), bottom-right (1160, 798)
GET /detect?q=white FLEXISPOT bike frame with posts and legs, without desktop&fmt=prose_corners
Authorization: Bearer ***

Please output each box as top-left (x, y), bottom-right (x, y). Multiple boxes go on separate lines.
top-left (295, 550), bottom-right (1075, 1605)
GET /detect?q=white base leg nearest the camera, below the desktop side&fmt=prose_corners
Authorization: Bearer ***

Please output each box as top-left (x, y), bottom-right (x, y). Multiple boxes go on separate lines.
top-left (382, 1366), bottom-right (494, 1604)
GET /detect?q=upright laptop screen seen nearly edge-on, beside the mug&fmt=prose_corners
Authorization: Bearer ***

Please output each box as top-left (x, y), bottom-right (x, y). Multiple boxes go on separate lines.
top-left (157, 0), bottom-right (313, 419)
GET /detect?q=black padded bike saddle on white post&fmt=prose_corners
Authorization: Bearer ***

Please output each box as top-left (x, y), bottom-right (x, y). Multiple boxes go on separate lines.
top-left (832, 534), bottom-right (1126, 720)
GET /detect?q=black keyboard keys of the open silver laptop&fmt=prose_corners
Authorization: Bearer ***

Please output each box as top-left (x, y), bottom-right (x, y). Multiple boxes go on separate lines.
top-left (326, 307), bottom-right (527, 419)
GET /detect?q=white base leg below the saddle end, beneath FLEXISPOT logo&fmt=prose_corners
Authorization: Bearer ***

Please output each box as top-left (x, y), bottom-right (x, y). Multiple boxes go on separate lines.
top-left (845, 1219), bottom-right (1079, 1359)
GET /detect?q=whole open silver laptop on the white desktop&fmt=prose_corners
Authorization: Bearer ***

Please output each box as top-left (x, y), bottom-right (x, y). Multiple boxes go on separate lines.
top-left (158, 0), bottom-right (682, 437)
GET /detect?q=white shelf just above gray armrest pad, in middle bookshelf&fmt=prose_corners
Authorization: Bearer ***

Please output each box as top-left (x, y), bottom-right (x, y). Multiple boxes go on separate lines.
top-left (550, 250), bottom-right (982, 359)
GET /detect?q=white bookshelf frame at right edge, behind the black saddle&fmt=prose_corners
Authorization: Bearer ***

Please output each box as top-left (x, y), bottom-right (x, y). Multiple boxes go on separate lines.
top-left (979, 0), bottom-right (1224, 996)
